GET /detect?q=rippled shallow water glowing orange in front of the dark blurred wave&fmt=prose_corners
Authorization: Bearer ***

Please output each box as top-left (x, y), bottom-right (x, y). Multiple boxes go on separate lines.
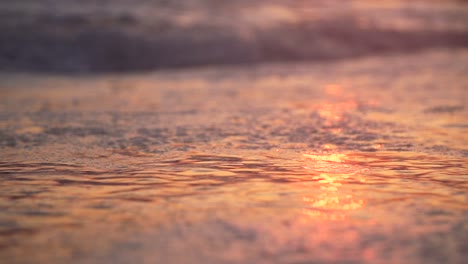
top-left (0, 51), bottom-right (468, 263)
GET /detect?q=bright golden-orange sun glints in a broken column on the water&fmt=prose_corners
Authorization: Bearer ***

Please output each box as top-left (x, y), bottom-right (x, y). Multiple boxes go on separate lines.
top-left (302, 84), bottom-right (370, 221)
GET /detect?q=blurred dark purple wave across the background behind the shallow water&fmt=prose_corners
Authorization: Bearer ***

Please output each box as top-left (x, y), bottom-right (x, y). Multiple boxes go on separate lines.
top-left (0, 0), bottom-right (468, 73)
